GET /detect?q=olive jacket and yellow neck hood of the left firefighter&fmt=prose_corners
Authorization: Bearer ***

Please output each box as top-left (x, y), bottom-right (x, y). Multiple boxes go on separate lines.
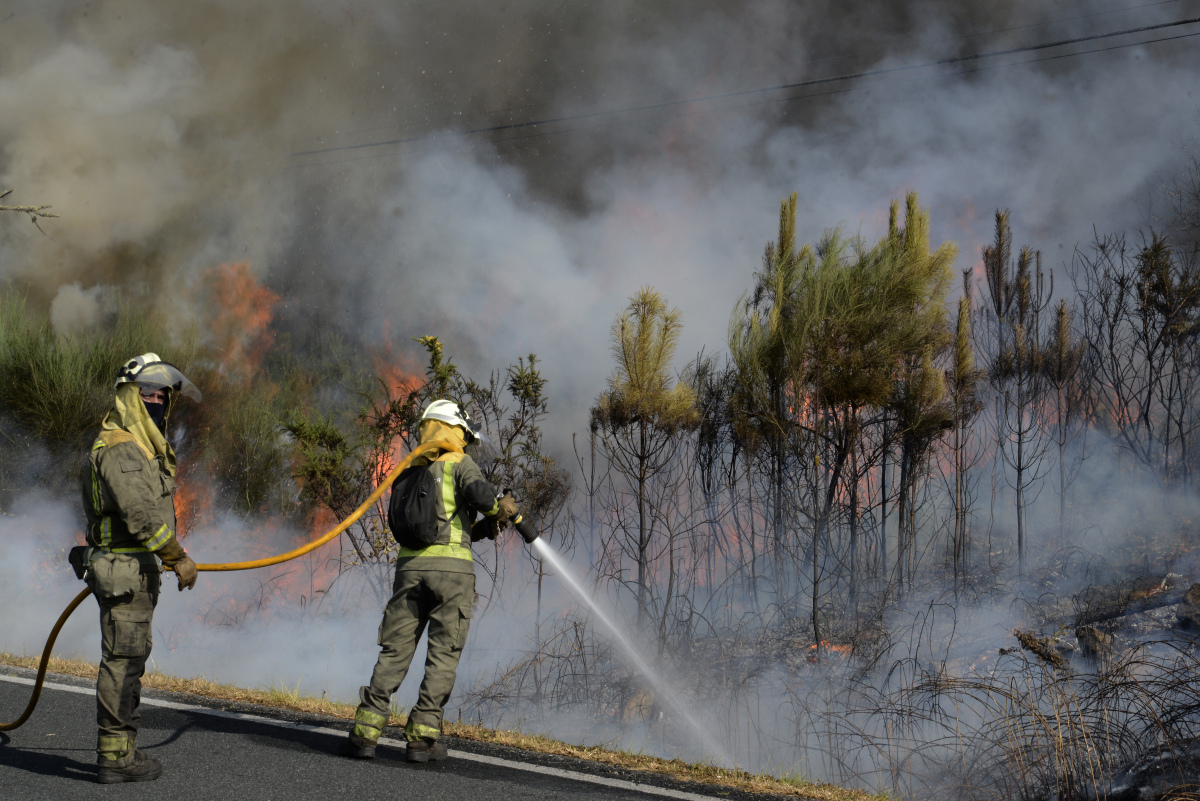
top-left (82, 384), bottom-right (175, 572)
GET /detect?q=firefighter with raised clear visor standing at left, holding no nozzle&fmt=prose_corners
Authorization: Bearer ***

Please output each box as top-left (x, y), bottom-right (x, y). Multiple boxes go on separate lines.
top-left (71, 354), bottom-right (200, 784)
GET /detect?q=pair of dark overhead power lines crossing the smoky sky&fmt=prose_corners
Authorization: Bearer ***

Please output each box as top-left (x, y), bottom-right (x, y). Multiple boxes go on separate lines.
top-left (292, 17), bottom-right (1200, 156)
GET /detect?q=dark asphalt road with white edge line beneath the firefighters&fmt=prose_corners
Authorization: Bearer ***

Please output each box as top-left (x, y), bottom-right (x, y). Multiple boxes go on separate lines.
top-left (0, 668), bottom-right (748, 801)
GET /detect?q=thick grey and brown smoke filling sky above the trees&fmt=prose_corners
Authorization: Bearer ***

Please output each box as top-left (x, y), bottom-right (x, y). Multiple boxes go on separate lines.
top-left (0, 0), bottom-right (1200, 442)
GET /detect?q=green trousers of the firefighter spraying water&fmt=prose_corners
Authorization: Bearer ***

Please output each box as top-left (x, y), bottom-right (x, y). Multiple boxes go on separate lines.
top-left (350, 566), bottom-right (475, 745)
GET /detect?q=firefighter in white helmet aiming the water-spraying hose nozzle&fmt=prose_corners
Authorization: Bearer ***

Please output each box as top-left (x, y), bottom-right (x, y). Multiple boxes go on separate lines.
top-left (347, 401), bottom-right (516, 763)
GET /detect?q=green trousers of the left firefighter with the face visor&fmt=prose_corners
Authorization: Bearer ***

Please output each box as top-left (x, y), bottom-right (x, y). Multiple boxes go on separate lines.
top-left (96, 573), bottom-right (160, 767)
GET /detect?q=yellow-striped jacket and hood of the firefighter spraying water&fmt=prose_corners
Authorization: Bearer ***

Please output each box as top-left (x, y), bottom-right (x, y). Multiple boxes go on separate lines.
top-left (396, 420), bottom-right (500, 576)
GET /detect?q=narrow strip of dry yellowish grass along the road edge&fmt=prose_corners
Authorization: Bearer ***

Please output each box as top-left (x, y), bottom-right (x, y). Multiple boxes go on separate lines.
top-left (0, 652), bottom-right (888, 801)
